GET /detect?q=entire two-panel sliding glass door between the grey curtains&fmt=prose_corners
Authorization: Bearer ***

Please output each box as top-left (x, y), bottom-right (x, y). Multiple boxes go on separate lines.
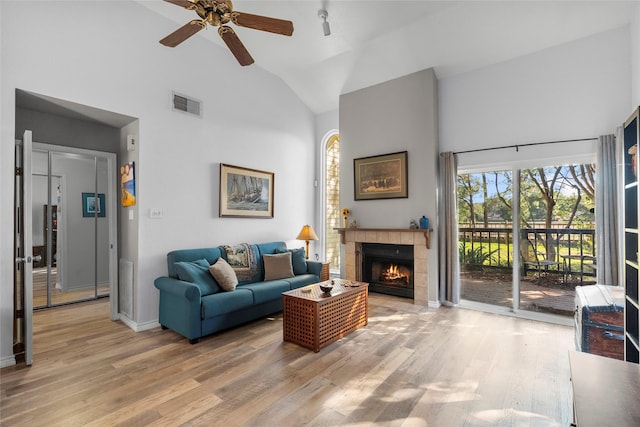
top-left (458, 164), bottom-right (597, 316)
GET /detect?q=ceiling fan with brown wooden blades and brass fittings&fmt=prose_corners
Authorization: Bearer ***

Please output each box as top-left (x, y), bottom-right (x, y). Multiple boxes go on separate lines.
top-left (160, 0), bottom-right (293, 66)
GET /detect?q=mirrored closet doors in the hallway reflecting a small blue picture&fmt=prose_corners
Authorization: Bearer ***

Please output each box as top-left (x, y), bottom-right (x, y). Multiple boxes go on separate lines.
top-left (31, 143), bottom-right (115, 309)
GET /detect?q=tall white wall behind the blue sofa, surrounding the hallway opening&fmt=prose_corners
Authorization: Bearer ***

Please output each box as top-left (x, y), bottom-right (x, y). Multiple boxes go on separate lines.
top-left (0, 1), bottom-right (316, 363)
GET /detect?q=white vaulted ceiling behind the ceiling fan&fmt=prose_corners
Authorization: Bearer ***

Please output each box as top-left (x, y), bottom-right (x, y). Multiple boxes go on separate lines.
top-left (141, 0), bottom-right (636, 113)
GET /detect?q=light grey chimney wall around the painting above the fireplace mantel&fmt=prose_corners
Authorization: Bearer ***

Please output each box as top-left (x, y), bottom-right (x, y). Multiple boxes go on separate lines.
top-left (340, 69), bottom-right (439, 303)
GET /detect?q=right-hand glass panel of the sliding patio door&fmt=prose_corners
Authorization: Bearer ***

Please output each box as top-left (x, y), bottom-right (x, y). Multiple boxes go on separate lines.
top-left (518, 164), bottom-right (596, 316)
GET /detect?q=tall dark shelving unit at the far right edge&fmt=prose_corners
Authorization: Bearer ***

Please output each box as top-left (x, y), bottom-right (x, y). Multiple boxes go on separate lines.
top-left (623, 108), bottom-right (640, 363)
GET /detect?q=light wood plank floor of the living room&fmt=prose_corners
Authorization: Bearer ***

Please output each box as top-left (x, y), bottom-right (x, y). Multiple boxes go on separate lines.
top-left (0, 294), bottom-right (573, 427)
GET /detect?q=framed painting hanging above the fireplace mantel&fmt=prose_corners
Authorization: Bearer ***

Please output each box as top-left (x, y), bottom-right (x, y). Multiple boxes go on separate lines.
top-left (353, 151), bottom-right (409, 200)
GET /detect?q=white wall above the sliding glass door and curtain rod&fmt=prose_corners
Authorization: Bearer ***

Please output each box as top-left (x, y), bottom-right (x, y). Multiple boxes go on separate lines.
top-left (439, 26), bottom-right (631, 168)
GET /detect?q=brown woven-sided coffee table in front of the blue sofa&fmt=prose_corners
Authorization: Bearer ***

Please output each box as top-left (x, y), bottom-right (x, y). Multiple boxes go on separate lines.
top-left (282, 279), bottom-right (369, 352)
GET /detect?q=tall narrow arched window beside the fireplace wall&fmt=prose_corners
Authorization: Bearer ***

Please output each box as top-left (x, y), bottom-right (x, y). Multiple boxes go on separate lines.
top-left (324, 133), bottom-right (341, 271)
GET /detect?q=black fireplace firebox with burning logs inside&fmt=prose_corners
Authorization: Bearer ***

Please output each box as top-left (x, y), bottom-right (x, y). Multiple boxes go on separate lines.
top-left (361, 243), bottom-right (413, 298)
